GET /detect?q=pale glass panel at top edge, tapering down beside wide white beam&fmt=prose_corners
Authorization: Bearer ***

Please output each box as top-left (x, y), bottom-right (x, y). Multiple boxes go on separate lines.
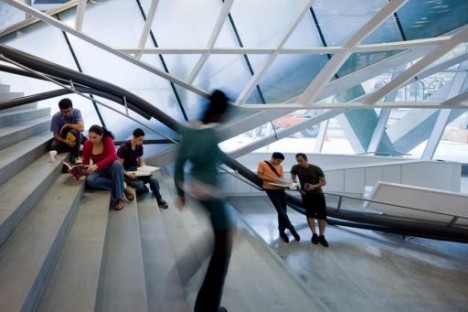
top-left (312, 0), bottom-right (387, 46)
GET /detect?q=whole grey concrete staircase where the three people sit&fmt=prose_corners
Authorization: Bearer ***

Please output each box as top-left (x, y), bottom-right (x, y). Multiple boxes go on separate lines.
top-left (0, 86), bottom-right (327, 312)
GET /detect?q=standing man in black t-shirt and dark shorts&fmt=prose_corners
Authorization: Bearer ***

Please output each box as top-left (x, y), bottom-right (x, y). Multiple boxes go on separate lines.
top-left (291, 153), bottom-right (328, 247)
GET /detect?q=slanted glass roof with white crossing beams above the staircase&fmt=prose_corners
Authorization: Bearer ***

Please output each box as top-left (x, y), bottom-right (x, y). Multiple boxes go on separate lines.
top-left (0, 0), bottom-right (468, 161)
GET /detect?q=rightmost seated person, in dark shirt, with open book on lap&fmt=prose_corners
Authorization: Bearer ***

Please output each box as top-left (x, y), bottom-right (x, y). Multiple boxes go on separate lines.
top-left (117, 128), bottom-right (169, 209)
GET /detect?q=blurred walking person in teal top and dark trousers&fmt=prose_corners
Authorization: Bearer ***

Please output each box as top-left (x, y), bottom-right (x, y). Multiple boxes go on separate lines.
top-left (174, 90), bottom-right (235, 312)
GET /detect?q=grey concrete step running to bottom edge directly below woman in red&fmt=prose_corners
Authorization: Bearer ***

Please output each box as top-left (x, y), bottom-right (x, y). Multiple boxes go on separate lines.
top-left (36, 191), bottom-right (110, 312)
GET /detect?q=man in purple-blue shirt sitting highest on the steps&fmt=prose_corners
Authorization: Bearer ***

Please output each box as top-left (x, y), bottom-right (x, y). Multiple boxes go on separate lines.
top-left (49, 98), bottom-right (84, 163)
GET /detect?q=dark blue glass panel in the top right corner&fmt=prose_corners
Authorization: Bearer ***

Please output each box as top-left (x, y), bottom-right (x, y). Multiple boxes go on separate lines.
top-left (397, 0), bottom-right (468, 40)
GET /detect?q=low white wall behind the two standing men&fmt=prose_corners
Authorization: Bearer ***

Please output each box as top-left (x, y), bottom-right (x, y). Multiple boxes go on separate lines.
top-left (222, 153), bottom-right (461, 195)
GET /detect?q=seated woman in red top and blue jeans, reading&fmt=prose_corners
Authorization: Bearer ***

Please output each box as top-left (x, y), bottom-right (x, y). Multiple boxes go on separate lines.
top-left (83, 125), bottom-right (134, 210)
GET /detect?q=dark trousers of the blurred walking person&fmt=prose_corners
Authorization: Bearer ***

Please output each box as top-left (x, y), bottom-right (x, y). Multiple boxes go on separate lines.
top-left (194, 200), bottom-right (234, 312)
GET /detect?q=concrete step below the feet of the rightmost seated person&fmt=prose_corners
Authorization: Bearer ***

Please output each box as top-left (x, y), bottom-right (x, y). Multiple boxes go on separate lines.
top-left (138, 193), bottom-right (190, 312)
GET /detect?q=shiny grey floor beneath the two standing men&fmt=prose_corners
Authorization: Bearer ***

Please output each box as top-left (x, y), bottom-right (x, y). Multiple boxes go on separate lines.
top-left (229, 196), bottom-right (468, 311)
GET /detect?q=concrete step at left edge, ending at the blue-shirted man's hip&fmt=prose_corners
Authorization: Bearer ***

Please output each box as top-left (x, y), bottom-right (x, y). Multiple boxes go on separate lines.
top-left (0, 131), bottom-right (50, 185)
